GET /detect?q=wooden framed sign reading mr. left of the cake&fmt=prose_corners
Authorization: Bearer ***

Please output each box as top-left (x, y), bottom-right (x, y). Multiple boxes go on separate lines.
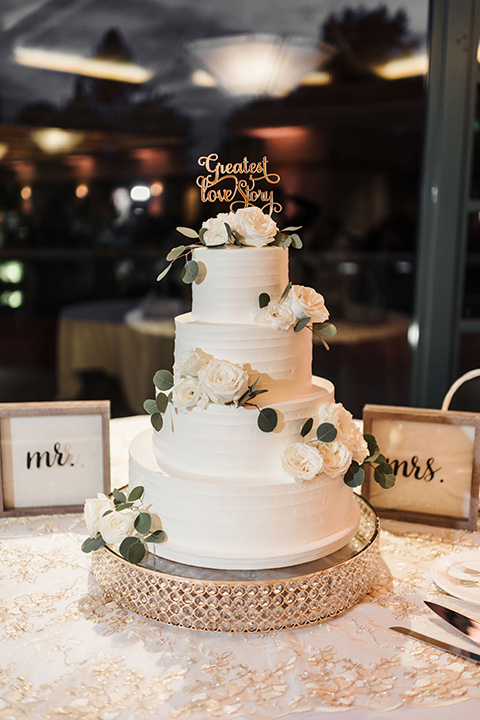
top-left (0, 400), bottom-right (110, 517)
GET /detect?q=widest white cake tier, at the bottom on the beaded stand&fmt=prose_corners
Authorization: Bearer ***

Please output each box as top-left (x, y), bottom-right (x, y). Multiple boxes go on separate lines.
top-left (129, 430), bottom-right (360, 570)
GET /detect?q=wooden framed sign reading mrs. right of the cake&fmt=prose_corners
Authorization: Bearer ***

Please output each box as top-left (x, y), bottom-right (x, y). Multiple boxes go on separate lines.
top-left (362, 405), bottom-right (480, 530)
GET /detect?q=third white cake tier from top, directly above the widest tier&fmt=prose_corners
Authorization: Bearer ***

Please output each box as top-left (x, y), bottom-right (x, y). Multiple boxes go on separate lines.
top-left (153, 376), bottom-right (334, 478)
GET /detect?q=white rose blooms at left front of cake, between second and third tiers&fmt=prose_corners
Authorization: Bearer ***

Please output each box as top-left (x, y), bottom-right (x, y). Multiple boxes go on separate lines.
top-left (172, 350), bottom-right (248, 411)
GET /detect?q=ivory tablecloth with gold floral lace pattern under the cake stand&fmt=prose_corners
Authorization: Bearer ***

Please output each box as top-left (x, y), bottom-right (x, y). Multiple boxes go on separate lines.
top-left (0, 417), bottom-right (480, 720)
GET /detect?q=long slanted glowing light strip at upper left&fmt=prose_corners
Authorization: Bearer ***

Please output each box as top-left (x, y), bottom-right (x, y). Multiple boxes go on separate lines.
top-left (15, 47), bottom-right (154, 84)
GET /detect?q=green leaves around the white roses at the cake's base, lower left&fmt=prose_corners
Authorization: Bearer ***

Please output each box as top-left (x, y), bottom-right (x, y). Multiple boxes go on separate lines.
top-left (82, 485), bottom-right (167, 565)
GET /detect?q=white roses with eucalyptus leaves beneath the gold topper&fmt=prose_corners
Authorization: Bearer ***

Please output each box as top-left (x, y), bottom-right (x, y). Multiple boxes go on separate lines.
top-left (157, 205), bottom-right (302, 284)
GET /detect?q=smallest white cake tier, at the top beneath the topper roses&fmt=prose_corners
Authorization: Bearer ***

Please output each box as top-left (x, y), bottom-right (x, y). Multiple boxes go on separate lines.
top-left (192, 245), bottom-right (288, 325)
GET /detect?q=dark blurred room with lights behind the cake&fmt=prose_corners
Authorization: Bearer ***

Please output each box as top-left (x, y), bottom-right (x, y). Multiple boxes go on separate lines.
top-left (0, 0), bottom-right (480, 417)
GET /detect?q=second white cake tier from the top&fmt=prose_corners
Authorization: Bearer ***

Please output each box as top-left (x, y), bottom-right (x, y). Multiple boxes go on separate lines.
top-left (175, 313), bottom-right (312, 399)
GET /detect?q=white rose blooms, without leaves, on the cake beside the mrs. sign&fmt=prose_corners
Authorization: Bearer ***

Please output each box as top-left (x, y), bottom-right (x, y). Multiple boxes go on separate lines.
top-left (281, 403), bottom-right (369, 482)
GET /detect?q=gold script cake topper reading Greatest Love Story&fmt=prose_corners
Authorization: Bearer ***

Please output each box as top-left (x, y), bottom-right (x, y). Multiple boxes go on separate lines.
top-left (197, 153), bottom-right (282, 215)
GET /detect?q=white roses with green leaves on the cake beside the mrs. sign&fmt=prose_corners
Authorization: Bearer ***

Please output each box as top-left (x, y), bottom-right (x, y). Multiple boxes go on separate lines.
top-left (280, 403), bottom-right (396, 488)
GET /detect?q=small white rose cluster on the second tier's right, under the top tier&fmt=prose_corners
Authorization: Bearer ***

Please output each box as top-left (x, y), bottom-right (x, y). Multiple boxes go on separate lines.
top-left (255, 285), bottom-right (329, 330)
